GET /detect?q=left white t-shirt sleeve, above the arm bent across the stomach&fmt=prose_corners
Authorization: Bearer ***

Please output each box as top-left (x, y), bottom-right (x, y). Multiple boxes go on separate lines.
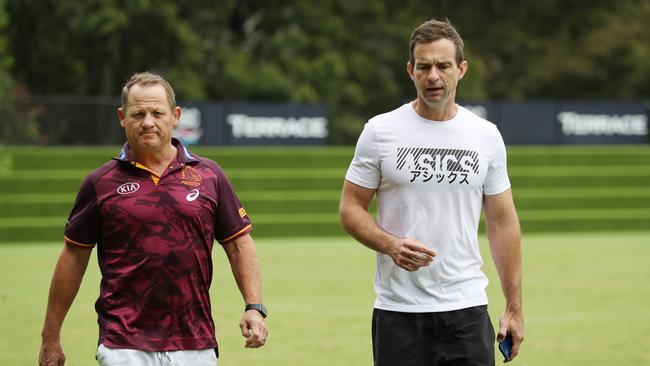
top-left (345, 123), bottom-right (381, 189)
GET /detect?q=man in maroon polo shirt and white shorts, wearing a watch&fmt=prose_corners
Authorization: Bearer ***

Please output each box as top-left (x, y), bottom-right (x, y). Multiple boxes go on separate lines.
top-left (39, 73), bottom-right (268, 366)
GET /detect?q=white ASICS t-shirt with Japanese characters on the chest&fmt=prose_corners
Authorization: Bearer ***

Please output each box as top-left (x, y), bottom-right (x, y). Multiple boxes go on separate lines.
top-left (345, 103), bottom-right (510, 312)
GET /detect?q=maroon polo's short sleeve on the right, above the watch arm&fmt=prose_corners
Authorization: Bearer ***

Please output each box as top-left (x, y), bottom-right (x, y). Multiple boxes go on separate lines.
top-left (214, 168), bottom-right (253, 244)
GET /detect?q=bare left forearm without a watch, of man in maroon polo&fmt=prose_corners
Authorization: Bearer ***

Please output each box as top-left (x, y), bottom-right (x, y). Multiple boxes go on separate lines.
top-left (41, 245), bottom-right (90, 342)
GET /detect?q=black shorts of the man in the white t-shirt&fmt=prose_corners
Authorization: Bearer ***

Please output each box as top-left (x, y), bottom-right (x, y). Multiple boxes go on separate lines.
top-left (372, 305), bottom-right (495, 366)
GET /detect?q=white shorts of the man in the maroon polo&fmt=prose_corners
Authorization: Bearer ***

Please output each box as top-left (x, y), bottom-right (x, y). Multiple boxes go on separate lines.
top-left (97, 344), bottom-right (217, 366)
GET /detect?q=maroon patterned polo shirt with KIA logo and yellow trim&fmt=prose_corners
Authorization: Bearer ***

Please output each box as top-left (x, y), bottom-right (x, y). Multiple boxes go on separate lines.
top-left (65, 139), bottom-right (251, 351)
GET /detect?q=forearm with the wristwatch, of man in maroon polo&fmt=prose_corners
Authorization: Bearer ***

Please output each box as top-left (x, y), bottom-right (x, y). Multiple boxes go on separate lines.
top-left (224, 235), bottom-right (262, 304)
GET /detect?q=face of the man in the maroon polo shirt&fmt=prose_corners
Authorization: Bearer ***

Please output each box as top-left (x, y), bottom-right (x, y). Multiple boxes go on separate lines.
top-left (117, 84), bottom-right (181, 150)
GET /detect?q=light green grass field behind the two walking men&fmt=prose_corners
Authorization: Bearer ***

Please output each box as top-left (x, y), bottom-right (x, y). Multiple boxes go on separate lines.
top-left (0, 232), bottom-right (650, 366)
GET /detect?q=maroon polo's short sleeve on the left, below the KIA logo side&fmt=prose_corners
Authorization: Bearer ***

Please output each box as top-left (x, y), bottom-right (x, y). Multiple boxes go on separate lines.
top-left (65, 176), bottom-right (100, 248)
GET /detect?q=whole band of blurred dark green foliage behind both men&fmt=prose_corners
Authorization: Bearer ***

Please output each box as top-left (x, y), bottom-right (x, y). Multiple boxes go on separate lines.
top-left (0, 0), bottom-right (650, 144)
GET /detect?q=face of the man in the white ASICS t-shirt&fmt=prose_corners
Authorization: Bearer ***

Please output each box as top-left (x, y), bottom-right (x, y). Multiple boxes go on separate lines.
top-left (406, 38), bottom-right (467, 109)
